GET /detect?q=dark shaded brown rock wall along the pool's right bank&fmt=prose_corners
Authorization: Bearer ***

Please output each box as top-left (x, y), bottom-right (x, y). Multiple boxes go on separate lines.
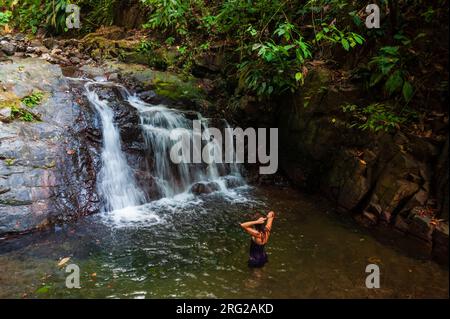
top-left (278, 68), bottom-right (449, 262)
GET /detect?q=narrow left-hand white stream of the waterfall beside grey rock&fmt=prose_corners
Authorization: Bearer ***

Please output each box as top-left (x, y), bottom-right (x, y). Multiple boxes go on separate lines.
top-left (85, 82), bottom-right (145, 211)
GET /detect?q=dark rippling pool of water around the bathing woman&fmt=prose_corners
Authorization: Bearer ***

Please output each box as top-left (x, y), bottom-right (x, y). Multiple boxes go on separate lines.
top-left (0, 187), bottom-right (448, 298)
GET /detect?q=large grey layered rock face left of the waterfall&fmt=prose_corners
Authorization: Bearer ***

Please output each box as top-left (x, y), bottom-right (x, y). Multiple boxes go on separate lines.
top-left (0, 59), bottom-right (99, 235)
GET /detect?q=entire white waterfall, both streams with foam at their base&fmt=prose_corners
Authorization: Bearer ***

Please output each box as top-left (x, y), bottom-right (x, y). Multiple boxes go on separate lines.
top-left (78, 78), bottom-right (246, 226)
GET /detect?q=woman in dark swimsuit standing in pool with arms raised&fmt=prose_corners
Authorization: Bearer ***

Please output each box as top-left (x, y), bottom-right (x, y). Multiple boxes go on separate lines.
top-left (241, 212), bottom-right (275, 268)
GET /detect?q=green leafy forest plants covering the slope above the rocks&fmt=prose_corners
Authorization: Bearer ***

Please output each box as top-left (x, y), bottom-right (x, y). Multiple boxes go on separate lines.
top-left (0, 0), bottom-right (448, 134)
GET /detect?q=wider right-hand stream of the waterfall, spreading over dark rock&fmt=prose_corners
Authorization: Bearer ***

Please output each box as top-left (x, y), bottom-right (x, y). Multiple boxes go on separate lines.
top-left (126, 92), bottom-right (245, 197)
